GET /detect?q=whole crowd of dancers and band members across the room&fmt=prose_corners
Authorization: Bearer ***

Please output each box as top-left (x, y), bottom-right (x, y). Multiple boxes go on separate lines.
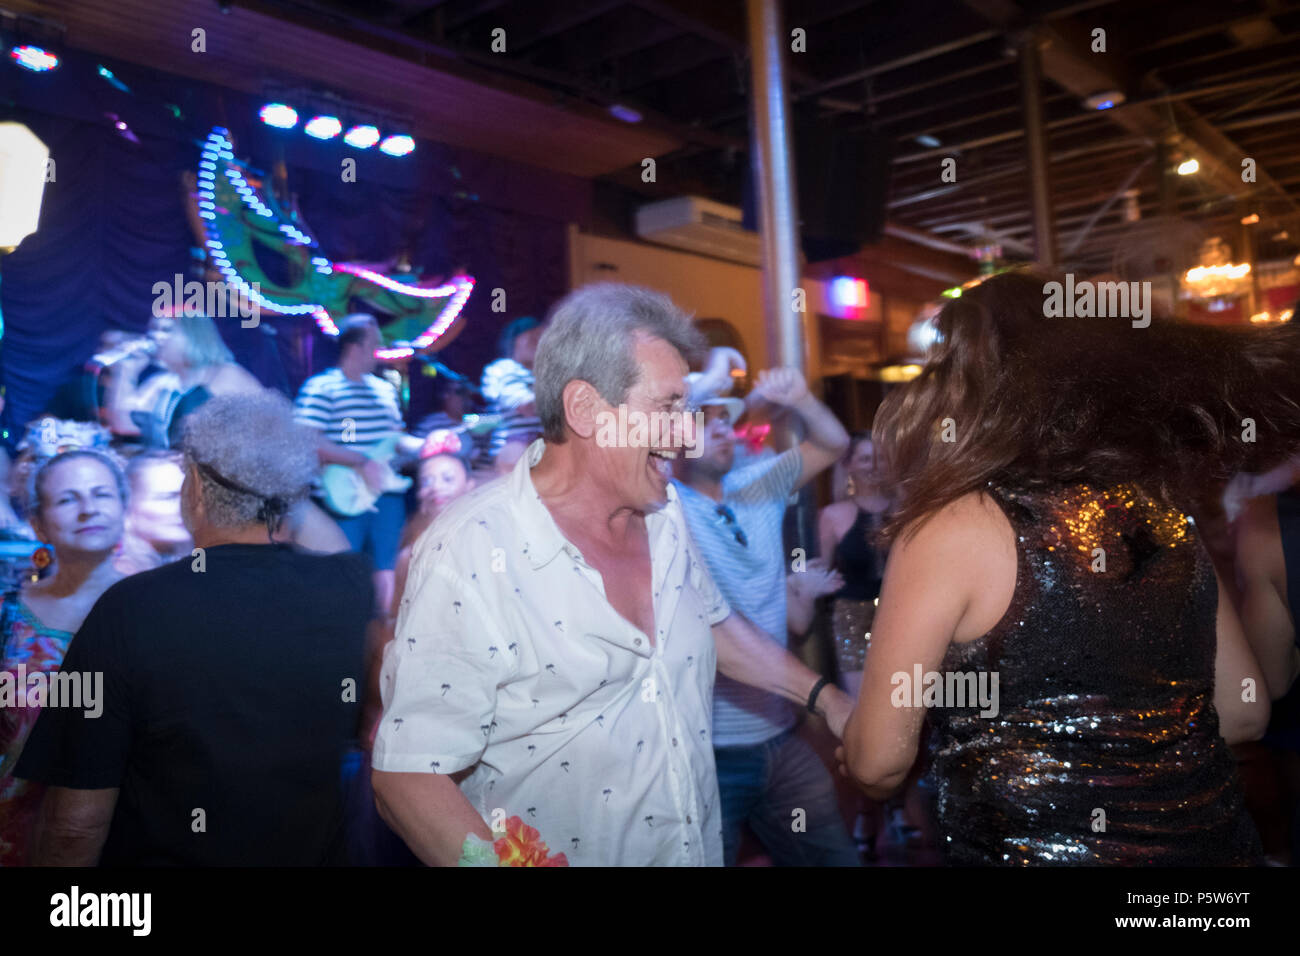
top-left (0, 273), bottom-right (1300, 866)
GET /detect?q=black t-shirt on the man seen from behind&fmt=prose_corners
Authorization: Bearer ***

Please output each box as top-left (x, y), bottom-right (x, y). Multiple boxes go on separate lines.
top-left (16, 545), bottom-right (373, 866)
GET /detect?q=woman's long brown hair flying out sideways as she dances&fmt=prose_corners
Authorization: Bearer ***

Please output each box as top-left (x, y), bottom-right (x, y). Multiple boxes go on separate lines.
top-left (872, 271), bottom-right (1300, 537)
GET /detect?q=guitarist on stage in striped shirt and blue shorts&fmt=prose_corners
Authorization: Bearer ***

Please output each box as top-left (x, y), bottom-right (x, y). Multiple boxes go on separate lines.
top-left (294, 315), bottom-right (420, 613)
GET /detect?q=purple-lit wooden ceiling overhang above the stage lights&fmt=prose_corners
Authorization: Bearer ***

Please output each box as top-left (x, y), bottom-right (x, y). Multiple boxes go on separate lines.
top-left (0, 0), bottom-right (683, 177)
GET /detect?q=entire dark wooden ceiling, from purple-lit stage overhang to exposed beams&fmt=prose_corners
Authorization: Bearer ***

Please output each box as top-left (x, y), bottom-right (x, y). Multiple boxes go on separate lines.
top-left (10, 0), bottom-right (1300, 268)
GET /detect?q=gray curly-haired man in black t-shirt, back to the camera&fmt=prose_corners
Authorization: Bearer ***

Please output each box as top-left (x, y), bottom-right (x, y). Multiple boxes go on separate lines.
top-left (21, 392), bottom-right (374, 866)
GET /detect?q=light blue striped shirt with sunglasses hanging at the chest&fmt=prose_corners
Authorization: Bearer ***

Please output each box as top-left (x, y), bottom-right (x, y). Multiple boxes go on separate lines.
top-left (673, 447), bottom-right (803, 747)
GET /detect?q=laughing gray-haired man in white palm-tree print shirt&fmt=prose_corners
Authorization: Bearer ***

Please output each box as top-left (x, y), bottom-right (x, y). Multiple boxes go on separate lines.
top-left (373, 285), bottom-right (852, 866)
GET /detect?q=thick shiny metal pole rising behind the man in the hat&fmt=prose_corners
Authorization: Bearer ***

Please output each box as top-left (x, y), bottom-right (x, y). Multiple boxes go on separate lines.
top-left (748, 0), bottom-right (806, 371)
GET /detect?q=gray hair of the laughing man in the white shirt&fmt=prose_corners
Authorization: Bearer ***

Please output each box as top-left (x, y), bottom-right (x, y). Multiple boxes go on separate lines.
top-left (533, 282), bottom-right (707, 442)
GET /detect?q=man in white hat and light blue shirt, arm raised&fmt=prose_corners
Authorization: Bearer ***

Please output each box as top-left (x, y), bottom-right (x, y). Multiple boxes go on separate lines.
top-left (675, 368), bottom-right (859, 866)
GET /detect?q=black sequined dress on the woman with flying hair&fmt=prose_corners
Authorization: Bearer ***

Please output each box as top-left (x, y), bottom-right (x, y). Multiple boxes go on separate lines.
top-left (930, 484), bottom-right (1262, 866)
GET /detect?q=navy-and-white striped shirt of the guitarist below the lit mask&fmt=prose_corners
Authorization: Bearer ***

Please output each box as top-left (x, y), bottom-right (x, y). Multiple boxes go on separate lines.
top-left (294, 368), bottom-right (406, 447)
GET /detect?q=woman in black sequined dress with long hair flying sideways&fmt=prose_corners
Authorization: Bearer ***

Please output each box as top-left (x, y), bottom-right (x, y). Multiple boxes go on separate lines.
top-left (842, 273), bottom-right (1300, 865)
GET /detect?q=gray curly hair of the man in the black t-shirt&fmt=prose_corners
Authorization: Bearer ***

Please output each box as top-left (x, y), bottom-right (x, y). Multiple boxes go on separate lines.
top-left (183, 390), bottom-right (319, 528)
